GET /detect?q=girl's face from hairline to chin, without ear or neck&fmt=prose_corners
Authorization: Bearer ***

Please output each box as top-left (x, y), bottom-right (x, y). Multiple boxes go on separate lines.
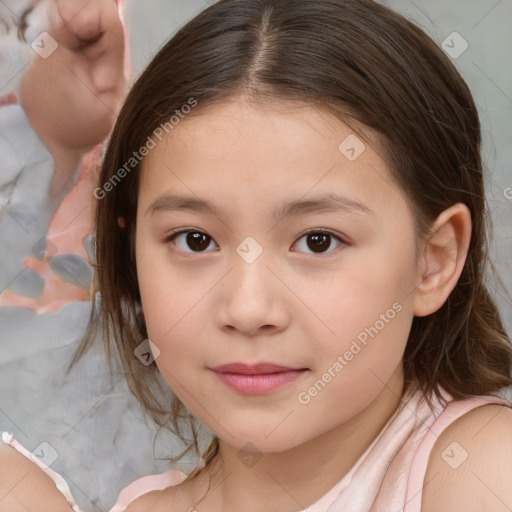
top-left (136, 99), bottom-right (419, 452)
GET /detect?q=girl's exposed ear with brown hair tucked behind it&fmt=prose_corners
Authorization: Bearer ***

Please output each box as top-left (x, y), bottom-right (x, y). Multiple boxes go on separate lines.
top-left (413, 203), bottom-right (472, 316)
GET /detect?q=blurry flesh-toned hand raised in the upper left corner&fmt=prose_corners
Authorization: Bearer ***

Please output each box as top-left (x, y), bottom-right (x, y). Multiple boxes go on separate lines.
top-left (19, 0), bottom-right (126, 197)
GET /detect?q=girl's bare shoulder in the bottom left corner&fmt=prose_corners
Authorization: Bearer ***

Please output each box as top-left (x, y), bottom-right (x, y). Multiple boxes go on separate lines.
top-left (0, 441), bottom-right (71, 512)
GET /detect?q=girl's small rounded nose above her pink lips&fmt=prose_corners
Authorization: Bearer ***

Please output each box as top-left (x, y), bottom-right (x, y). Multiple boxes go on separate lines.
top-left (216, 250), bottom-right (290, 337)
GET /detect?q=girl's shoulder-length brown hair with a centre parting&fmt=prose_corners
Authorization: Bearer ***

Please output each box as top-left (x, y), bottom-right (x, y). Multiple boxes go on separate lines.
top-left (68, 0), bottom-right (512, 476)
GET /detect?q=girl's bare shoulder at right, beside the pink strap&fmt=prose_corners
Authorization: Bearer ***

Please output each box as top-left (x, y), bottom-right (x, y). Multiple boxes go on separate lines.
top-left (421, 404), bottom-right (512, 512)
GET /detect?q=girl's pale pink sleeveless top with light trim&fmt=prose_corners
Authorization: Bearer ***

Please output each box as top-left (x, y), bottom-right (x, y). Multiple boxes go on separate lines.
top-left (2, 390), bottom-right (511, 512)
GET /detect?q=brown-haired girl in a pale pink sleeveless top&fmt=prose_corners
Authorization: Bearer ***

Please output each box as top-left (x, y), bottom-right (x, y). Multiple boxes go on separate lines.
top-left (0, 0), bottom-right (512, 512)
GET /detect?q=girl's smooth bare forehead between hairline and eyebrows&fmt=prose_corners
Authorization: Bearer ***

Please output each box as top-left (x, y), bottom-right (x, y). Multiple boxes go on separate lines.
top-left (139, 99), bottom-right (403, 220)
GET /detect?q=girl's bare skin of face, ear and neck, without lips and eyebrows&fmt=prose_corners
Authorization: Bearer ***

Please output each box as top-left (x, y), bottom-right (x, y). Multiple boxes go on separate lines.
top-left (132, 98), bottom-right (471, 512)
